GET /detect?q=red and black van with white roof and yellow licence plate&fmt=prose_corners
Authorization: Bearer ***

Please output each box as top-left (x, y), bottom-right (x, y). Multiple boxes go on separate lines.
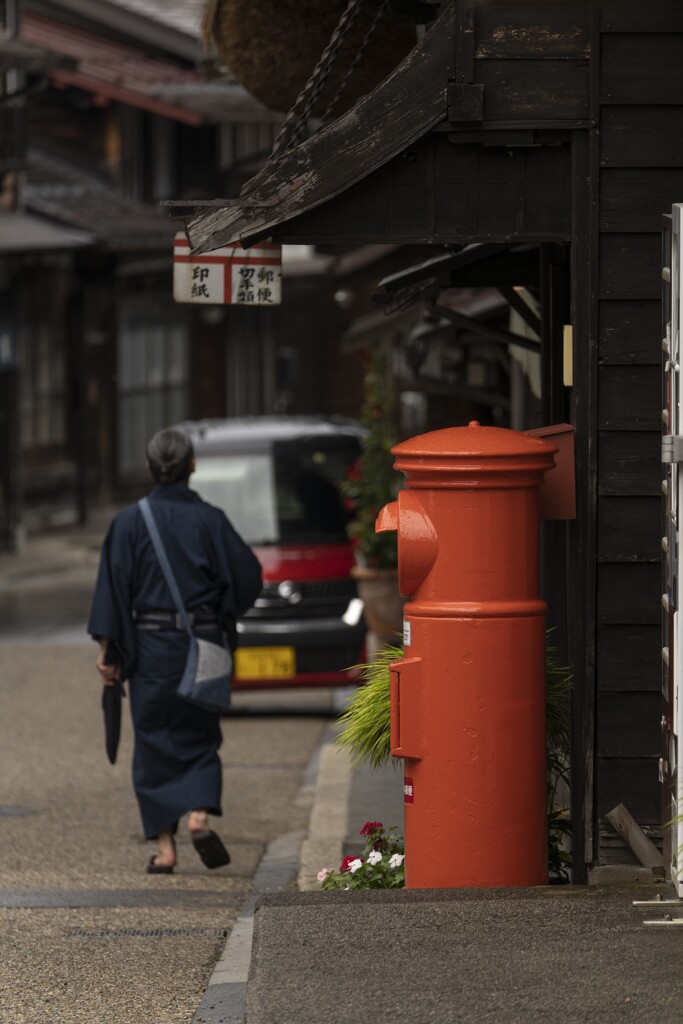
top-left (179, 417), bottom-right (366, 689)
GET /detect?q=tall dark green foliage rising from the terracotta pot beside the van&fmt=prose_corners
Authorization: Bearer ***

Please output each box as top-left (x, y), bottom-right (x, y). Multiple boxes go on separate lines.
top-left (342, 346), bottom-right (399, 568)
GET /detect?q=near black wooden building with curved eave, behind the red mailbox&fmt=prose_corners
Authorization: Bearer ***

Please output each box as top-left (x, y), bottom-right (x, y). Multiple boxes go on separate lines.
top-left (187, 0), bottom-right (683, 881)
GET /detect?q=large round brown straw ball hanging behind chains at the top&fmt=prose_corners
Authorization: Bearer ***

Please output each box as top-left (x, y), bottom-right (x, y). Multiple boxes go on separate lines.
top-left (206, 0), bottom-right (417, 119)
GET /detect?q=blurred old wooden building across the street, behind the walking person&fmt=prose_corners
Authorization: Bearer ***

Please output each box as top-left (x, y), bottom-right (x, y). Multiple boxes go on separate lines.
top-left (0, 0), bottom-right (359, 549)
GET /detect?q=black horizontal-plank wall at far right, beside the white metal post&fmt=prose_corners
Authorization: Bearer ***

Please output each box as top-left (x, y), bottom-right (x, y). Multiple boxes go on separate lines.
top-left (595, 6), bottom-right (683, 824)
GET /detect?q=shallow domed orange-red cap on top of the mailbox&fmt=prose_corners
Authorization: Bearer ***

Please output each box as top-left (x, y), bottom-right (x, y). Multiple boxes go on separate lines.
top-left (391, 420), bottom-right (558, 460)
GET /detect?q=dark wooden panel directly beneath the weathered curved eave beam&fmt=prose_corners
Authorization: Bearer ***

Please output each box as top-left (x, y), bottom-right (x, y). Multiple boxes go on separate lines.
top-left (284, 135), bottom-right (570, 244)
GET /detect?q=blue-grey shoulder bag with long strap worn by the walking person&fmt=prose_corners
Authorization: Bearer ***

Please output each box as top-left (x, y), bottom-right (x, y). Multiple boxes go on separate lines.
top-left (138, 498), bottom-right (232, 714)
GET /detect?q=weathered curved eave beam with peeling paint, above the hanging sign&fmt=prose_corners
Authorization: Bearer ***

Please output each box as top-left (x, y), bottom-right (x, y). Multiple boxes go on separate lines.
top-left (186, 3), bottom-right (456, 253)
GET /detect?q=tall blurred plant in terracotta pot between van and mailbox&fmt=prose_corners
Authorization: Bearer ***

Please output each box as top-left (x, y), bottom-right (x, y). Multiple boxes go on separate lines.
top-left (342, 346), bottom-right (403, 642)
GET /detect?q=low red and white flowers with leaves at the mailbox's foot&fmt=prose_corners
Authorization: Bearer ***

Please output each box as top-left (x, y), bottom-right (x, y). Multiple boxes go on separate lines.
top-left (317, 821), bottom-right (405, 890)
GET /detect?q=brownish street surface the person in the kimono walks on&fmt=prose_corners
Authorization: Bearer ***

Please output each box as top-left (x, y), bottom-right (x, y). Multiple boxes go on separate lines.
top-left (0, 566), bottom-right (334, 1024)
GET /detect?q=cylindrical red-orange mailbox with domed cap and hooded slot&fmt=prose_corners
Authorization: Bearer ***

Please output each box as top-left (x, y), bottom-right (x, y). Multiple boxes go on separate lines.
top-left (376, 422), bottom-right (557, 889)
